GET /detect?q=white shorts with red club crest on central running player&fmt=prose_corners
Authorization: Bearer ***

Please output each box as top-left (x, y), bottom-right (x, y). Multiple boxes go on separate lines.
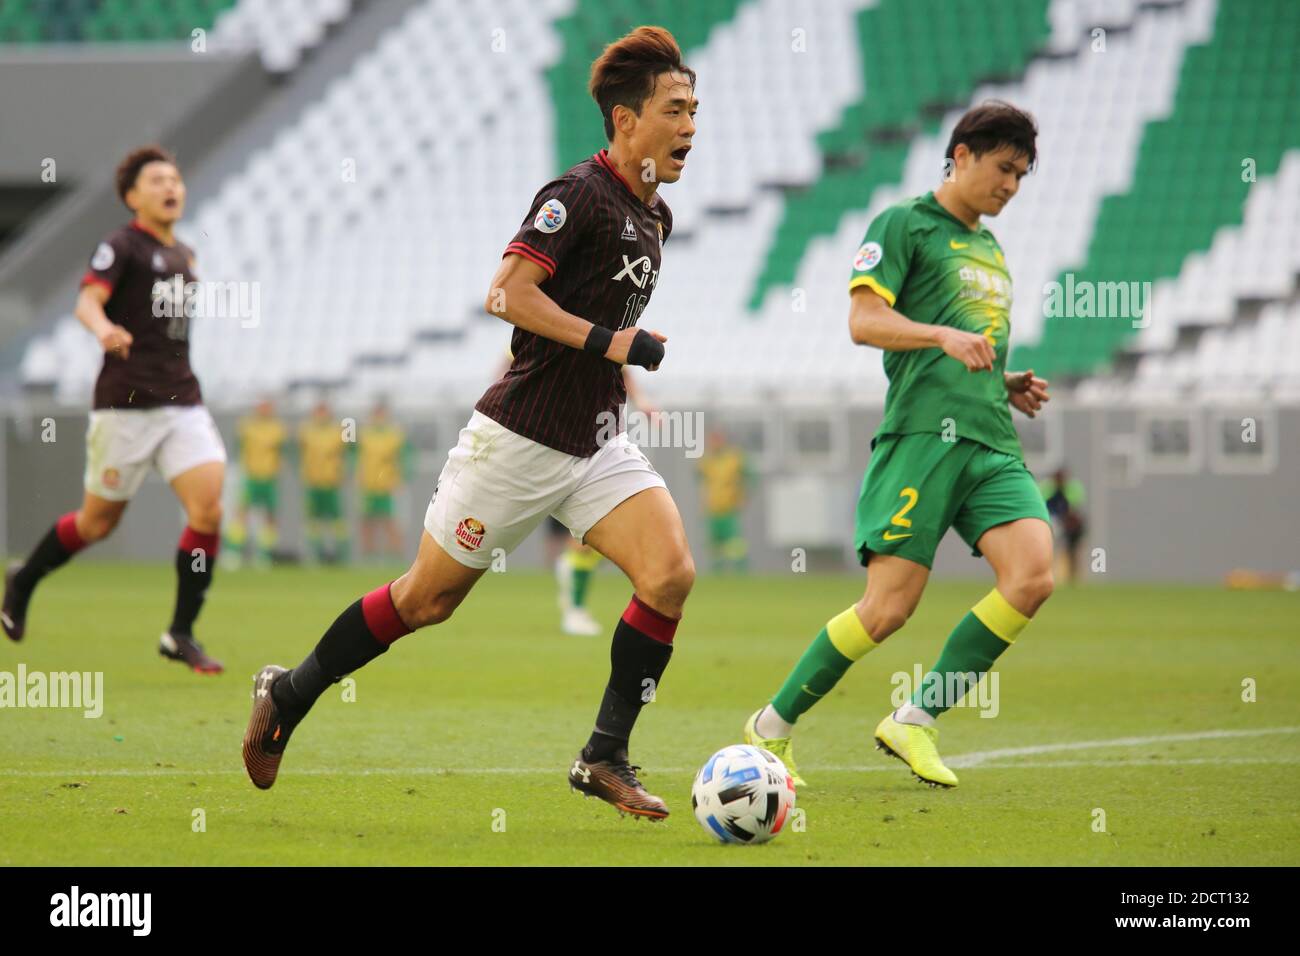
top-left (424, 411), bottom-right (667, 567)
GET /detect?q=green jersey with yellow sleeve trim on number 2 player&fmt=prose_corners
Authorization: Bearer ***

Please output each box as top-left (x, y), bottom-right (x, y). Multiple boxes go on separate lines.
top-left (849, 193), bottom-right (1023, 458)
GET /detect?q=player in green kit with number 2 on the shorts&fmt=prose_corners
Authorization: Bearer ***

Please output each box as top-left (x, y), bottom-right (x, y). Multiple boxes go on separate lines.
top-left (745, 101), bottom-right (1052, 787)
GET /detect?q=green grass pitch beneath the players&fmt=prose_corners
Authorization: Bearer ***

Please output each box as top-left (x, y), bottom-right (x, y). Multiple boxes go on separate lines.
top-left (0, 561), bottom-right (1300, 866)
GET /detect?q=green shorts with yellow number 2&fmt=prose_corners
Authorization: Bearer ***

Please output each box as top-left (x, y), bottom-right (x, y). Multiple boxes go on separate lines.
top-left (853, 433), bottom-right (1050, 567)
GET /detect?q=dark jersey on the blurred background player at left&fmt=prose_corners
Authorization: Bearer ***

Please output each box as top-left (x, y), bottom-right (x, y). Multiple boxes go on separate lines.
top-left (82, 222), bottom-right (203, 408)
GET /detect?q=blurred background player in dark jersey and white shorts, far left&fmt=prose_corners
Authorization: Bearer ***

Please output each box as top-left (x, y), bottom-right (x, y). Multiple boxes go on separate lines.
top-left (0, 146), bottom-right (226, 674)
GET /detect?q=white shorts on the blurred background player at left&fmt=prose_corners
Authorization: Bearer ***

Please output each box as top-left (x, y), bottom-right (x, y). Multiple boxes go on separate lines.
top-left (86, 405), bottom-right (226, 501)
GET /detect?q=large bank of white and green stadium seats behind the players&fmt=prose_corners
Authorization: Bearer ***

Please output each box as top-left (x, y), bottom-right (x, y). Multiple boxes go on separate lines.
top-left (23, 0), bottom-right (1300, 405)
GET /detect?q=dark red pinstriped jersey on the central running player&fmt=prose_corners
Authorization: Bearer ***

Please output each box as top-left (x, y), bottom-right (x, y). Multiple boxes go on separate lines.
top-left (475, 150), bottom-right (672, 458)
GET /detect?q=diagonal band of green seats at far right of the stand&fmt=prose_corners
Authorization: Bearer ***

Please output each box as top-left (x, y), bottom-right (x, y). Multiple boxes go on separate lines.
top-left (1015, 0), bottom-right (1300, 376)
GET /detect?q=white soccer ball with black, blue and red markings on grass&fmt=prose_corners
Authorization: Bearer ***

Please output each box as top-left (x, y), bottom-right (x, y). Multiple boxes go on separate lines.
top-left (690, 744), bottom-right (794, 843)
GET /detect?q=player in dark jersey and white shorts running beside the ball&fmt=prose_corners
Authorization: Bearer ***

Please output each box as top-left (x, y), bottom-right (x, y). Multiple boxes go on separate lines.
top-left (243, 27), bottom-right (697, 819)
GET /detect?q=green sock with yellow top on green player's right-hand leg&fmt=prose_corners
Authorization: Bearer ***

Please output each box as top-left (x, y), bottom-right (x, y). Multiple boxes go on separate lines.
top-left (911, 588), bottom-right (1030, 717)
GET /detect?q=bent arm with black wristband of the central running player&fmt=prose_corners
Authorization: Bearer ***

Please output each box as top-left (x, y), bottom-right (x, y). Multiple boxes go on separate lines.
top-left (484, 252), bottom-right (668, 372)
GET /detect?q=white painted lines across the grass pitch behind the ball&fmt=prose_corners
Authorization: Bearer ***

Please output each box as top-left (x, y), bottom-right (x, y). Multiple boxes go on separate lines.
top-left (0, 727), bottom-right (1300, 779)
